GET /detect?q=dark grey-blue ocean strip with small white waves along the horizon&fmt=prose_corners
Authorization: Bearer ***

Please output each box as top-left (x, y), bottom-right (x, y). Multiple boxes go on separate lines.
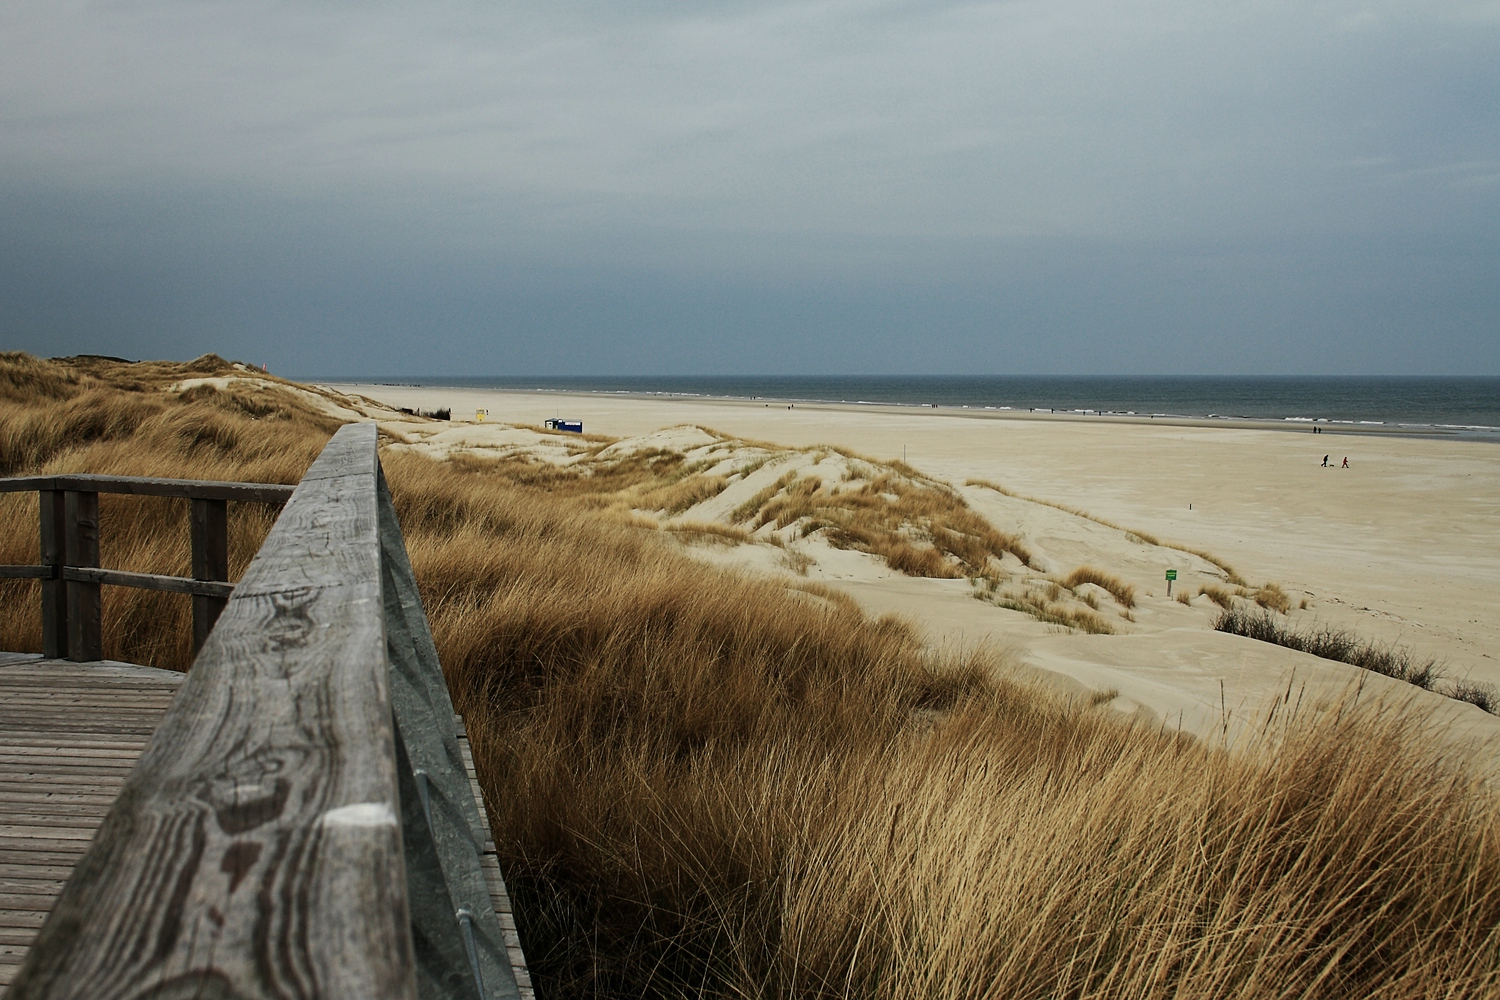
top-left (315, 375), bottom-right (1500, 436)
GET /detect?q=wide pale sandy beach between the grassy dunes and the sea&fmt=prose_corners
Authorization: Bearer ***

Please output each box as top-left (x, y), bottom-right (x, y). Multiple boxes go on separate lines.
top-left (330, 384), bottom-right (1500, 745)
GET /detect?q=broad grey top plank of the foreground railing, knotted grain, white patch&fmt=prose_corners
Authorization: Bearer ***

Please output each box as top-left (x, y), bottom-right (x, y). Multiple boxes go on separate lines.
top-left (0, 424), bottom-right (416, 1000)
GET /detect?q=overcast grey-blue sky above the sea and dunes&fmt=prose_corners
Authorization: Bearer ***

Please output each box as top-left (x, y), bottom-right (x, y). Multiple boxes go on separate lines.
top-left (0, 0), bottom-right (1500, 376)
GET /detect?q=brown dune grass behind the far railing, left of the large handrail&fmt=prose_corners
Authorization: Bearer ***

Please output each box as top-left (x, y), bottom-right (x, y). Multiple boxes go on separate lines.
top-left (0, 354), bottom-right (336, 669)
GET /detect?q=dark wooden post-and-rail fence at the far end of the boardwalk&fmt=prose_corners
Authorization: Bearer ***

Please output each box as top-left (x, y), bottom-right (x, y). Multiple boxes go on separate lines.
top-left (0, 475), bottom-right (293, 661)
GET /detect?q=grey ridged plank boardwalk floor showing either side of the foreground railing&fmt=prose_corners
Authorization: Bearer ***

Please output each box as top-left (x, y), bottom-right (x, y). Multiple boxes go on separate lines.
top-left (0, 652), bottom-right (534, 1000)
